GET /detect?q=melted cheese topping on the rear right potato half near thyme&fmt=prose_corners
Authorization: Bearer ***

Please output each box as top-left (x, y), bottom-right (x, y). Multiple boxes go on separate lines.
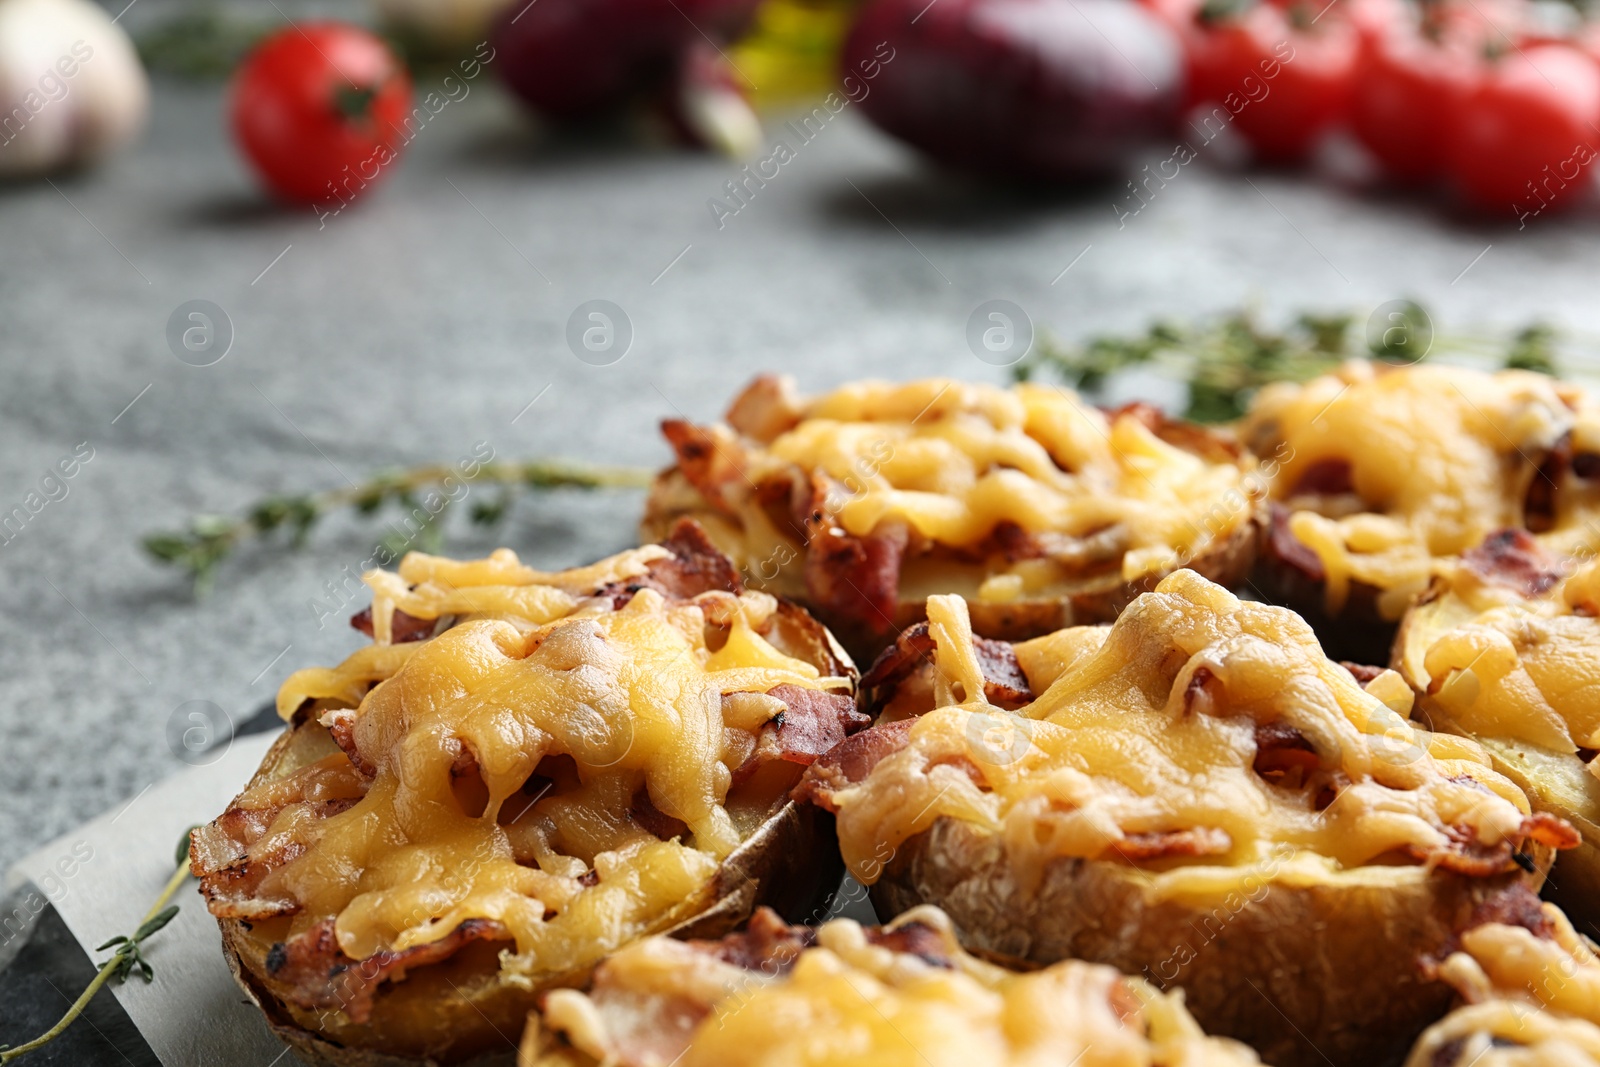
top-left (1243, 362), bottom-right (1600, 619)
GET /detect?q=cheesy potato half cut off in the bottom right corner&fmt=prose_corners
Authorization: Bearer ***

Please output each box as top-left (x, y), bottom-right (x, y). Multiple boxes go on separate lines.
top-left (1406, 894), bottom-right (1600, 1067)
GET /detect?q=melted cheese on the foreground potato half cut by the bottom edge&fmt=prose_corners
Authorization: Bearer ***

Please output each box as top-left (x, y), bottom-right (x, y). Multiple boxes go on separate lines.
top-left (546, 907), bottom-right (1259, 1067)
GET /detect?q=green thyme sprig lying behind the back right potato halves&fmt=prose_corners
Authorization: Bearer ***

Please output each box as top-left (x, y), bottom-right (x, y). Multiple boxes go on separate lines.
top-left (1013, 304), bottom-right (1557, 422)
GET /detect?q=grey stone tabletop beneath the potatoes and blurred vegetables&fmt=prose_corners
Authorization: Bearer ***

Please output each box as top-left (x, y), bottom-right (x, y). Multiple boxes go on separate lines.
top-left (0, 70), bottom-right (1600, 869)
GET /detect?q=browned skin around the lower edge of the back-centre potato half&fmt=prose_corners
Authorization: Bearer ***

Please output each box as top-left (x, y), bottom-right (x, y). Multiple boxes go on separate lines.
top-left (640, 467), bottom-right (1262, 664)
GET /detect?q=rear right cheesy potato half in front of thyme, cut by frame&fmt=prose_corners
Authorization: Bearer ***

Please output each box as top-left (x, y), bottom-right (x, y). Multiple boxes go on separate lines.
top-left (1240, 362), bottom-right (1600, 662)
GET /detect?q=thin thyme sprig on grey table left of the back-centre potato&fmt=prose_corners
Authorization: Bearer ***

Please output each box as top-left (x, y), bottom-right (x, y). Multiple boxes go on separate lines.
top-left (142, 459), bottom-right (651, 595)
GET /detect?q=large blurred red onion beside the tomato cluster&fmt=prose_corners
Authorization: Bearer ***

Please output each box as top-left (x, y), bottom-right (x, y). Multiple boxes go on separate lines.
top-left (843, 0), bottom-right (1182, 181)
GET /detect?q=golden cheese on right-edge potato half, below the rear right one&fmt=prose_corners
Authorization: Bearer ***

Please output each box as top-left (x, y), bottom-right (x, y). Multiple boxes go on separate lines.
top-left (1400, 561), bottom-right (1600, 764)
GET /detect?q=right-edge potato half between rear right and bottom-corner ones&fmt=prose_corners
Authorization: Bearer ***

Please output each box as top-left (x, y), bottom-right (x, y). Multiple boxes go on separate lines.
top-left (1394, 530), bottom-right (1600, 936)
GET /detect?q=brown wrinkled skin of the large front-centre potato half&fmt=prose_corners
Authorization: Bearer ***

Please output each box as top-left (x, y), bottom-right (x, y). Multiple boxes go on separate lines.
top-left (872, 817), bottom-right (1547, 1067)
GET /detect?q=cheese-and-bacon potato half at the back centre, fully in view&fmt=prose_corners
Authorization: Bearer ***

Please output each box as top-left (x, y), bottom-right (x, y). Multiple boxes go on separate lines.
top-left (643, 378), bottom-right (1264, 661)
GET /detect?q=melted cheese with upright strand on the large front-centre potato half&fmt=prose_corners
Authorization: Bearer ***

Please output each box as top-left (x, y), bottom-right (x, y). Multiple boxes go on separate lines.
top-left (834, 571), bottom-right (1528, 894)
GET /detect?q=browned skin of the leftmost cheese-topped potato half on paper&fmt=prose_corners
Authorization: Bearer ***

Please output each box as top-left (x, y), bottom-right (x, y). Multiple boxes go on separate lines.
top-left (218, 721), bottom-right (843, 1067)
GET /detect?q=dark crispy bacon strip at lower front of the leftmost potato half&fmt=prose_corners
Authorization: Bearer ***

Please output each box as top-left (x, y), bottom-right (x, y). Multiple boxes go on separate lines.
top-left (267, 918), bottom-right (510, 1024)
